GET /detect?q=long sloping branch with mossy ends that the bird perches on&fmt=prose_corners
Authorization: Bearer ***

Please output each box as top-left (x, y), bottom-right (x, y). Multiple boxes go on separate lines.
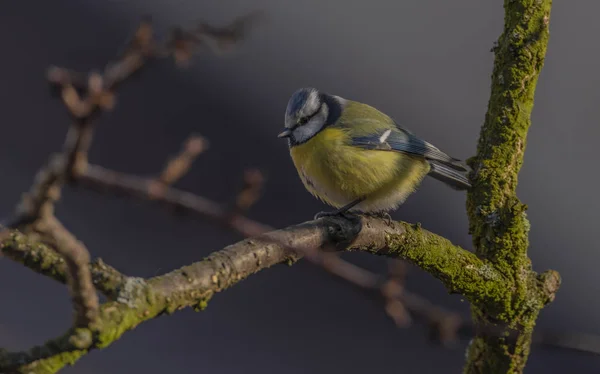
top-left (0, 218), bottom-right (524, 374)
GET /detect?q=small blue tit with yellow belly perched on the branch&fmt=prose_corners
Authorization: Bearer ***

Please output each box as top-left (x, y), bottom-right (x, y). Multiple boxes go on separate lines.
top-left (279, 88), bottom-right (471, 218)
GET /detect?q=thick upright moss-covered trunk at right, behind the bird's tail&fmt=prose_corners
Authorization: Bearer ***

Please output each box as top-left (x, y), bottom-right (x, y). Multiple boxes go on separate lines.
top-left (465, 0), bottom-right (560, 374)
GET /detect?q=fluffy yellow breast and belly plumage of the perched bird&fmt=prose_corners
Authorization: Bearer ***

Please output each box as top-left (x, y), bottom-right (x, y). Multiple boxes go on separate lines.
top-left (290, 127), bottom-right (429, 211)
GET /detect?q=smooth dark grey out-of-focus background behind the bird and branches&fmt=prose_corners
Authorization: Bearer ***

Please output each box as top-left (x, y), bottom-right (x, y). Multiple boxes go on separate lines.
top-left (0, 0), bottom-right (600, 374)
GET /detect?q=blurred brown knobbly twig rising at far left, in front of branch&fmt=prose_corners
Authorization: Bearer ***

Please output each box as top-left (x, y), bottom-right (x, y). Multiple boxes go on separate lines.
top-left (2, 14), bottom-right (256, 334)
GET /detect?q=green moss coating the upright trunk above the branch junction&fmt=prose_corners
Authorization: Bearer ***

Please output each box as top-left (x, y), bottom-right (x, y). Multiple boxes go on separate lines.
top-left (468, 0), bottom-right (551, 268)
